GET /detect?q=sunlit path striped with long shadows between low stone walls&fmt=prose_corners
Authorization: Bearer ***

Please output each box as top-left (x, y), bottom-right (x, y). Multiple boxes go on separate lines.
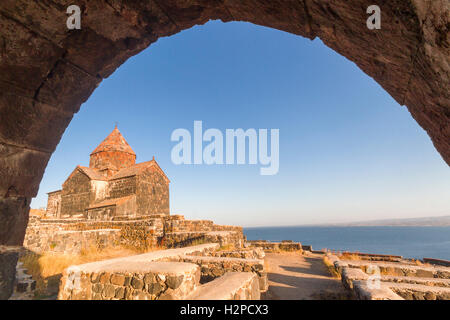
top-left (262, 252), bottom-right (349, 300)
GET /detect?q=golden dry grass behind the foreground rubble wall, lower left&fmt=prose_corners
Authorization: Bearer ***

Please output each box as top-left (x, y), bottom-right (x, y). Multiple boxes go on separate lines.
top-left (20, 247), bottom-right (163, 298)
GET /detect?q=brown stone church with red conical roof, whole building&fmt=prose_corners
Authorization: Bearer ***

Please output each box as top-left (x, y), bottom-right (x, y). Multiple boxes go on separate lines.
top-left (46, 127), bottom-right (169, 220)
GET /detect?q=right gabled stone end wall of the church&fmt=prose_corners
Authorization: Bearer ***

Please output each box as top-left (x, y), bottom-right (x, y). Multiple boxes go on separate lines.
top-left (136, 169), bottom-right (170, 215)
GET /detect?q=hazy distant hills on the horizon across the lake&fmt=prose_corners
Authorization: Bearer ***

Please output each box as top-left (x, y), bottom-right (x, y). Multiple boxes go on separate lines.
top-left (327, 216), bottom-right (450, 227)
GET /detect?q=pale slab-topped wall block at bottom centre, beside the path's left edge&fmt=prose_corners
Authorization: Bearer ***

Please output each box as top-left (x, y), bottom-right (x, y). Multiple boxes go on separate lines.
top-left (186, 272), bottom-right (260, 300)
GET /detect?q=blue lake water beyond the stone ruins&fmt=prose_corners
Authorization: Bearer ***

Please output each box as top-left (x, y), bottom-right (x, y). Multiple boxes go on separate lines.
top-left (244, 227), bottom-right (450, 260)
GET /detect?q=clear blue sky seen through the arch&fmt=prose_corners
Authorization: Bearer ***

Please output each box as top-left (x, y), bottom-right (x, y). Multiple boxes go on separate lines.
top-left (32, 21), bottom-right (450, 226)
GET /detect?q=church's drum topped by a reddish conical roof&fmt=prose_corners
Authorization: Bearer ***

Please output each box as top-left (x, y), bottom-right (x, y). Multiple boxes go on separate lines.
top-left (89, 127), bottom-right (136, 176)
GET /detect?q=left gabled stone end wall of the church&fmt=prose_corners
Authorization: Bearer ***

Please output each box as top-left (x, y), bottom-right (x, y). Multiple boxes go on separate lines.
top-left (61, 169), bottom-right (91, 217)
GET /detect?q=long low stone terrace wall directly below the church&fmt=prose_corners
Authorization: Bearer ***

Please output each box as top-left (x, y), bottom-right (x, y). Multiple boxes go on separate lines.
top-left (24, 215), bottom-right (245, 253)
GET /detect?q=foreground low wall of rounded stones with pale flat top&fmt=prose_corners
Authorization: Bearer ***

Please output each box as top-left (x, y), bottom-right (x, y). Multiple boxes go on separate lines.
top-left (58, 259), bottom-right (200, 300)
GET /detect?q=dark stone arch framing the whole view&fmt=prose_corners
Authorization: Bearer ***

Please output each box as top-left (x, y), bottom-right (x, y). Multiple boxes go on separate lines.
top-left (0, 0), bottom-right (450, 298)
